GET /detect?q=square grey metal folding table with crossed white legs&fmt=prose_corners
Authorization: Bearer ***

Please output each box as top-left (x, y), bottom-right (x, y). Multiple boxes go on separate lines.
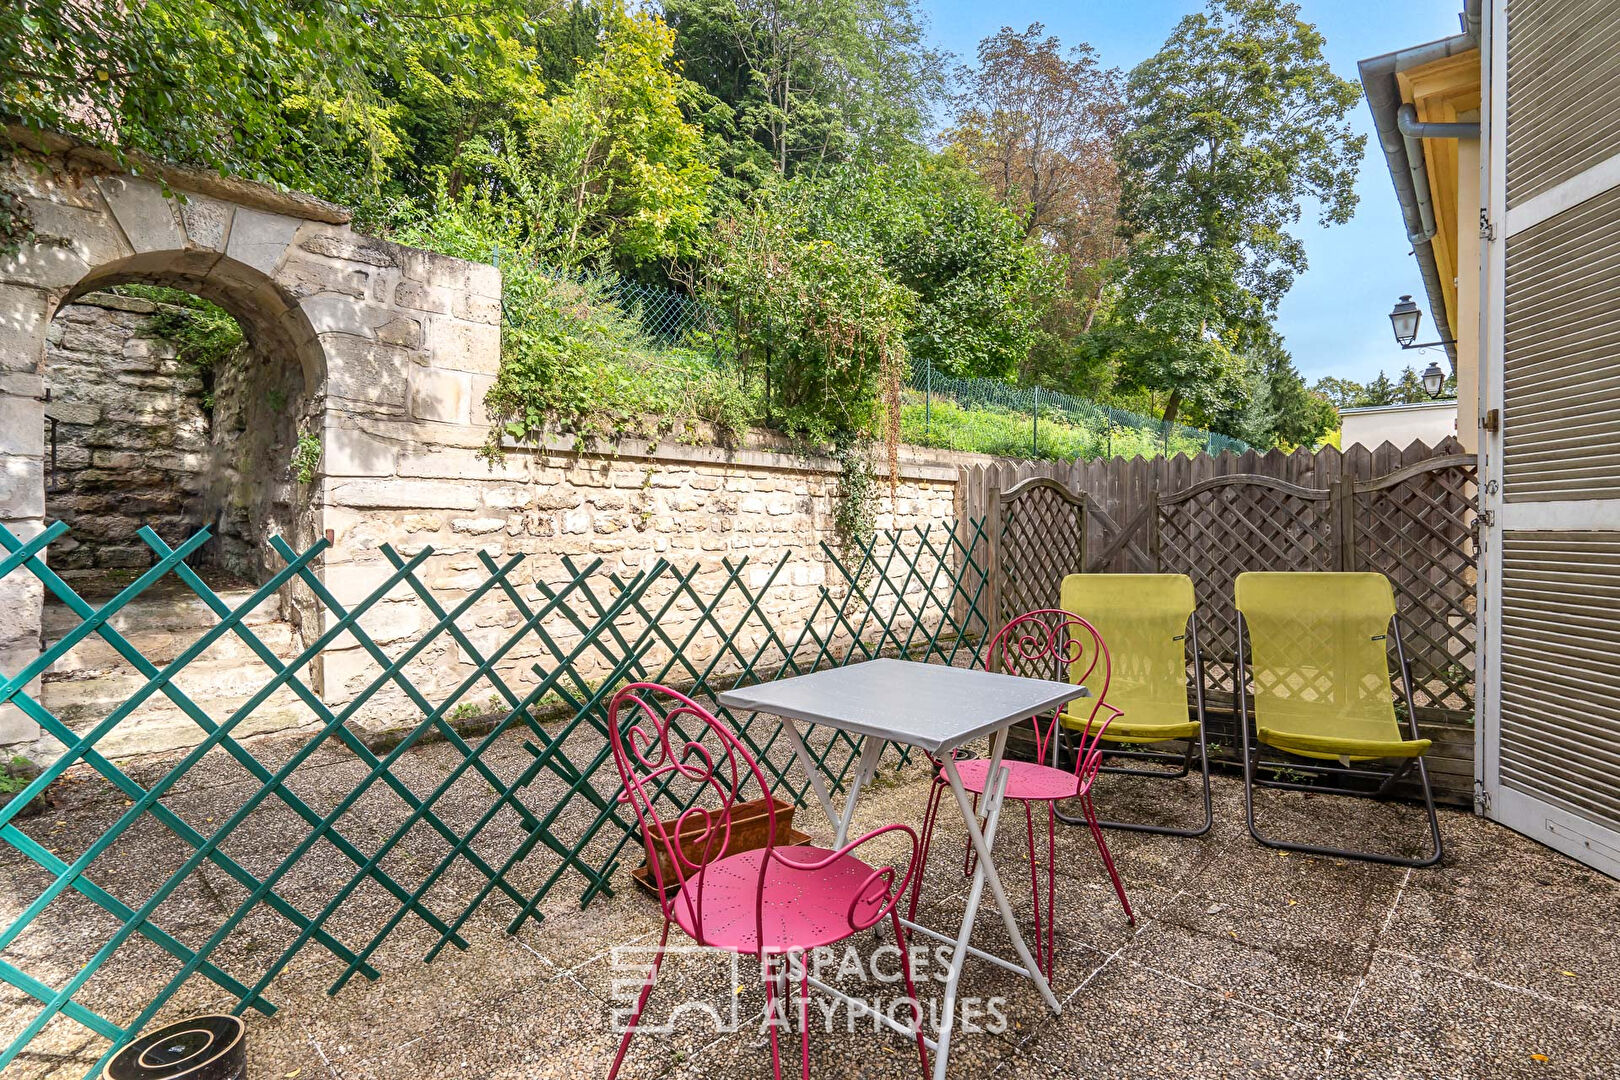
top-left (719, 659), bottom-right (1089, 1080)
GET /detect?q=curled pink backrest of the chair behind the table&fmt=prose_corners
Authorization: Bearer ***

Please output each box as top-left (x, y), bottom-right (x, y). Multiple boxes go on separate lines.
top-left (985, 607), bottom-right (1123, 789)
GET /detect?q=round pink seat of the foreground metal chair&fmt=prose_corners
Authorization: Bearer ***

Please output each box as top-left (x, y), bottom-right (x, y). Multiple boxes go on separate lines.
top-left (672, 847), bottom-right (888, 954)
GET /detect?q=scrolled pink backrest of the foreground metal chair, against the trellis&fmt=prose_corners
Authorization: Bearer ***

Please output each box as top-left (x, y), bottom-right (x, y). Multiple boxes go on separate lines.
top-left (608, 683), bottom-right (776, 944)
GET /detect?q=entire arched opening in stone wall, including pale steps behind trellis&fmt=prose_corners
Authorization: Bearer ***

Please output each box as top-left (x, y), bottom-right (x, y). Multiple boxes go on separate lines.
top-left (41, 251), bottom-right (326, 758)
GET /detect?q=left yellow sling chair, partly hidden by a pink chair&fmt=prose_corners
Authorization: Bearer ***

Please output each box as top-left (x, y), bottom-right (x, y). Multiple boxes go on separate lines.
top-left (1058, 573), bottom-right (1213, 836)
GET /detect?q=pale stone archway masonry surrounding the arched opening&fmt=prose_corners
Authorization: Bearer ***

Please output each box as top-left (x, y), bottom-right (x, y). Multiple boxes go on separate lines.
top-left (0, 130), bottom-right (501, 757)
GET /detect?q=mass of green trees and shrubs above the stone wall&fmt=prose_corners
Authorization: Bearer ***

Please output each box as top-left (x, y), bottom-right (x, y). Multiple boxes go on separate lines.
top-left (0, 0), bottom-right (1386, 459)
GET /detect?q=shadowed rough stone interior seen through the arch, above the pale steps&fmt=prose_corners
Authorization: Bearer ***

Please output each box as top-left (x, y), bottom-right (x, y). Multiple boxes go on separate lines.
top-left (44, 282), bottom-right (314, 599)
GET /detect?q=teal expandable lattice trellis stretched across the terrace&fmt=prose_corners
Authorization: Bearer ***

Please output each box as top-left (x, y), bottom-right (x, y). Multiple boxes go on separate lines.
top-left (0, 521), bottom-right (988, 1075)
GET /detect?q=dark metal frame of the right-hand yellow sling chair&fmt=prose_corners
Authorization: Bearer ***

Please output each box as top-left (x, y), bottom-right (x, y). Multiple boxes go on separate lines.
top-left (1236, 612), bottom-right (1445, 868)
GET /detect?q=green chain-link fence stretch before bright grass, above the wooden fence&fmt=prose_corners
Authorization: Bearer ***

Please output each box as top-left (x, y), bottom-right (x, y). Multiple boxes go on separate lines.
top-left (901, 363), bottom-right (1249, 458)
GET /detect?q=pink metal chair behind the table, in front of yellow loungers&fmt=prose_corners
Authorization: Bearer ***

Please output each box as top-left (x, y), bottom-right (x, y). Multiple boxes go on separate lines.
top-left (909, 609), bottom-right (1136, 978)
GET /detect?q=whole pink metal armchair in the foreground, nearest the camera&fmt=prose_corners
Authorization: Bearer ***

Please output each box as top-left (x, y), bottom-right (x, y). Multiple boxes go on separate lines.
top-left (608, 683), bottom-right (928, 1080)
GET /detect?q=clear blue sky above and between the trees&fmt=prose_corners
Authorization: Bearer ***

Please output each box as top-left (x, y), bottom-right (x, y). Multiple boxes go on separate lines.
top-left (922, 0), bottom-right (1463, 382)
